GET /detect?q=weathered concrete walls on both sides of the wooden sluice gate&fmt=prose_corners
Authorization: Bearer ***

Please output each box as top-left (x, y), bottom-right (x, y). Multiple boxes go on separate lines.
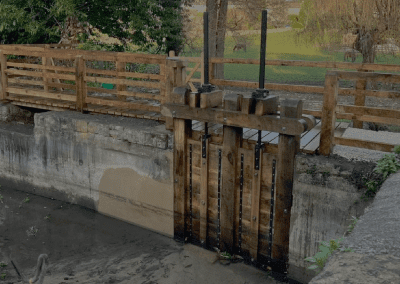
top-left (0, 105), bottom-right (390, 283)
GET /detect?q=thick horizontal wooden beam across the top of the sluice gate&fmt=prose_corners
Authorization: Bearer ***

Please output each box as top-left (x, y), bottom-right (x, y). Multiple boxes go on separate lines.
top-left (161, 104), bottom-right (304, 135)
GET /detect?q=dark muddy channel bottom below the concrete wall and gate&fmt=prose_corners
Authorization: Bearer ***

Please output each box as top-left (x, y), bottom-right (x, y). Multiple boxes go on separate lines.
top-left (0, 188), bottom-right (288, 284)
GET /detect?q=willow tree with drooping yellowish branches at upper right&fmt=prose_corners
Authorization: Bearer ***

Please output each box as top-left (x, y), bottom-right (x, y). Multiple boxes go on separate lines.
top-left (290, 0), bottom-right (400, 63)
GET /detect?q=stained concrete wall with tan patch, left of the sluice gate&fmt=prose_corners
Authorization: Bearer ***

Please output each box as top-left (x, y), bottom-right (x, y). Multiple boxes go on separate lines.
top-left (0, 105), bottom-right (173, 236)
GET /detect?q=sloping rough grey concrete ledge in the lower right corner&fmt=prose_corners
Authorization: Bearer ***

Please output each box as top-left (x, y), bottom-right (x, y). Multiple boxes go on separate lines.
top-left (310, 171), bottom-right (400, 284)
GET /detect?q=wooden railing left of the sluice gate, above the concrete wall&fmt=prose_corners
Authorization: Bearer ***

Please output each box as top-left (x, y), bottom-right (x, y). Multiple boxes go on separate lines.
top-left (0, 45), bottom-right (166, 116)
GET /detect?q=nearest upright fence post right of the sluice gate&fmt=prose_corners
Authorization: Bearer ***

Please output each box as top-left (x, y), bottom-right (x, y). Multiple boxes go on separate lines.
top-left (319, 70), bottom-right (338, 156)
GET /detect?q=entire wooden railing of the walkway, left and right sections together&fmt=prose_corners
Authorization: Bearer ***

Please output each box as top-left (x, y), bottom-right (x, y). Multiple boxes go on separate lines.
top-left (0, 45), bottom-right (400, 155)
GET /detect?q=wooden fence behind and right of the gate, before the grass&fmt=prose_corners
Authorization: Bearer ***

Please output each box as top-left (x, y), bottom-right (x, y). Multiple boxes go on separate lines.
top-left (179, 53), bottom-right (400, 155)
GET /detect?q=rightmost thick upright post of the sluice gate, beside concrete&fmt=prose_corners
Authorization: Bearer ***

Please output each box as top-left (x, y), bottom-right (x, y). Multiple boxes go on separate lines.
top-left (272, 100), bottom-right (303, 264)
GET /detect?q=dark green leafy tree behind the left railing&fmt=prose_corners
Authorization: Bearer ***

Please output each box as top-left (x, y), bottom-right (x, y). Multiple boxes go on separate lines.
top-left (0, 0), bottom-right (191, 55)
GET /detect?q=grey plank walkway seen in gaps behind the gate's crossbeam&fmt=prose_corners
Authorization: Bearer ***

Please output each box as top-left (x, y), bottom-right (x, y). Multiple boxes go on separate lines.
top-left (192, 119), bottom-right (349, 154)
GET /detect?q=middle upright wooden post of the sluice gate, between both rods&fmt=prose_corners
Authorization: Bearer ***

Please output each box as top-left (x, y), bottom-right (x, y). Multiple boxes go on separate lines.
top-left (220, 94), bottom-right (243, 253)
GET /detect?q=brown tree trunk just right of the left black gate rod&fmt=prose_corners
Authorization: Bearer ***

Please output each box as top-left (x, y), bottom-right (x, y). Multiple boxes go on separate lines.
top-left (207, 0), bottom-right (228, 88)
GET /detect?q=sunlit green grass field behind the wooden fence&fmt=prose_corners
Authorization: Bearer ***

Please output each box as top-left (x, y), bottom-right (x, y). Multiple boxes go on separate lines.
top-left (181, 28), bottom-right (400, 85)
